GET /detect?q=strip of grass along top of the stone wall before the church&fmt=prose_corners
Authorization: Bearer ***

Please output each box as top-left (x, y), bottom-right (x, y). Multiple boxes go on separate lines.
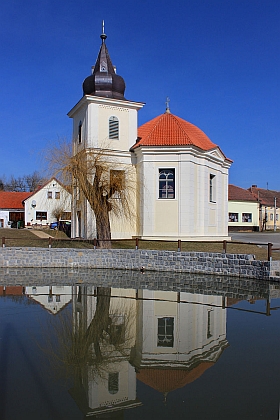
top-left (0, 228), bottom-right (280, 261)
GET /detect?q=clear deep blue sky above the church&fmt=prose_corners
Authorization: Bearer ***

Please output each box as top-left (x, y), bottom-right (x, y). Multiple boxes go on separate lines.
top-left (0, 0), bottom-right (280, 190)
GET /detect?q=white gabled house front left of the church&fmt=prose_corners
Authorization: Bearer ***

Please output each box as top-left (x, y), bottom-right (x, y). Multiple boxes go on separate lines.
top-left (24, 178), bottom-right (72, 226)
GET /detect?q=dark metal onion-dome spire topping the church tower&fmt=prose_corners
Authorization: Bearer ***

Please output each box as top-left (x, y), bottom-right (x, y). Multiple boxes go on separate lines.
top-left (83, 27), bottom-right (125, 100)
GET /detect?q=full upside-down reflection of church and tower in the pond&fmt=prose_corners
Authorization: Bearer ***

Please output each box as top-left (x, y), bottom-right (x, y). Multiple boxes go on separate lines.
top-left (71, 286), bottom-right (227, 418)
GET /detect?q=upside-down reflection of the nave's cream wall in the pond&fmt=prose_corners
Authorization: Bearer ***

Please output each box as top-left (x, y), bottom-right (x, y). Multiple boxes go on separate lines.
top-left (134, 290), bottom-right (228, 369)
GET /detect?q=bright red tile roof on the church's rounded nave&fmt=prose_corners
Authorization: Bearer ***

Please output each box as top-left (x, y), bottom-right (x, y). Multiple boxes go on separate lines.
top-left (132, 112), bottom-right (217, 150)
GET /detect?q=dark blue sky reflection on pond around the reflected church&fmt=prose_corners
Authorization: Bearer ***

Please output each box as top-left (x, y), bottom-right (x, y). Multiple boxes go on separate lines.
top-left (0, 282), bottom-right (280, 420)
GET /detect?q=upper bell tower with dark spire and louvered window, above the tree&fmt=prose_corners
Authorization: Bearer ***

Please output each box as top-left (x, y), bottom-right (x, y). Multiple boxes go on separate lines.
top-left (68, 22), bottom-right (144, 155)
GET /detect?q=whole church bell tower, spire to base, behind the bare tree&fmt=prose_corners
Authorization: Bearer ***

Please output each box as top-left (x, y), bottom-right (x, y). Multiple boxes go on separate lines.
top-left (68, 22), bottom-right (144, 239)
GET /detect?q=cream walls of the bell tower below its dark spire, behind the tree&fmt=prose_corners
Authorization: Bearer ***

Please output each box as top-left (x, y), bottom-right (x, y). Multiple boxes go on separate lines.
top-left (68, 95), bottom-right (144, 239)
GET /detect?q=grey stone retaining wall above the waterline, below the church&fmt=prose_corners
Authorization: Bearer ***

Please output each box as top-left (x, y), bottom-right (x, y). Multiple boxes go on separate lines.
top-left (0, 248), bottom-right (270, 280)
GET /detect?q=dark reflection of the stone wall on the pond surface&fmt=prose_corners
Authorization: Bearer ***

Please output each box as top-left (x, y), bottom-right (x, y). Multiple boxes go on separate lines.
top-left (0, 268), bottom-right (280, 301)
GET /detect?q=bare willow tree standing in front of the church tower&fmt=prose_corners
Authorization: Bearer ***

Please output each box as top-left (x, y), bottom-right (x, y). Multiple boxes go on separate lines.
top-left (47, 141), bottom-right (136, 248)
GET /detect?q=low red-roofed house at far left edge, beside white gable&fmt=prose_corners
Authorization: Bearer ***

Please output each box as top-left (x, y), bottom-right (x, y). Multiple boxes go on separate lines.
top-left (0, 191), bottom-right (32, 228)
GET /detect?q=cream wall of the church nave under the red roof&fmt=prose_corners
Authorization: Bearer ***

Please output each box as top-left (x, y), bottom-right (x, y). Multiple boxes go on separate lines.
top-left (135, 146), bottom-right (230, 240)
